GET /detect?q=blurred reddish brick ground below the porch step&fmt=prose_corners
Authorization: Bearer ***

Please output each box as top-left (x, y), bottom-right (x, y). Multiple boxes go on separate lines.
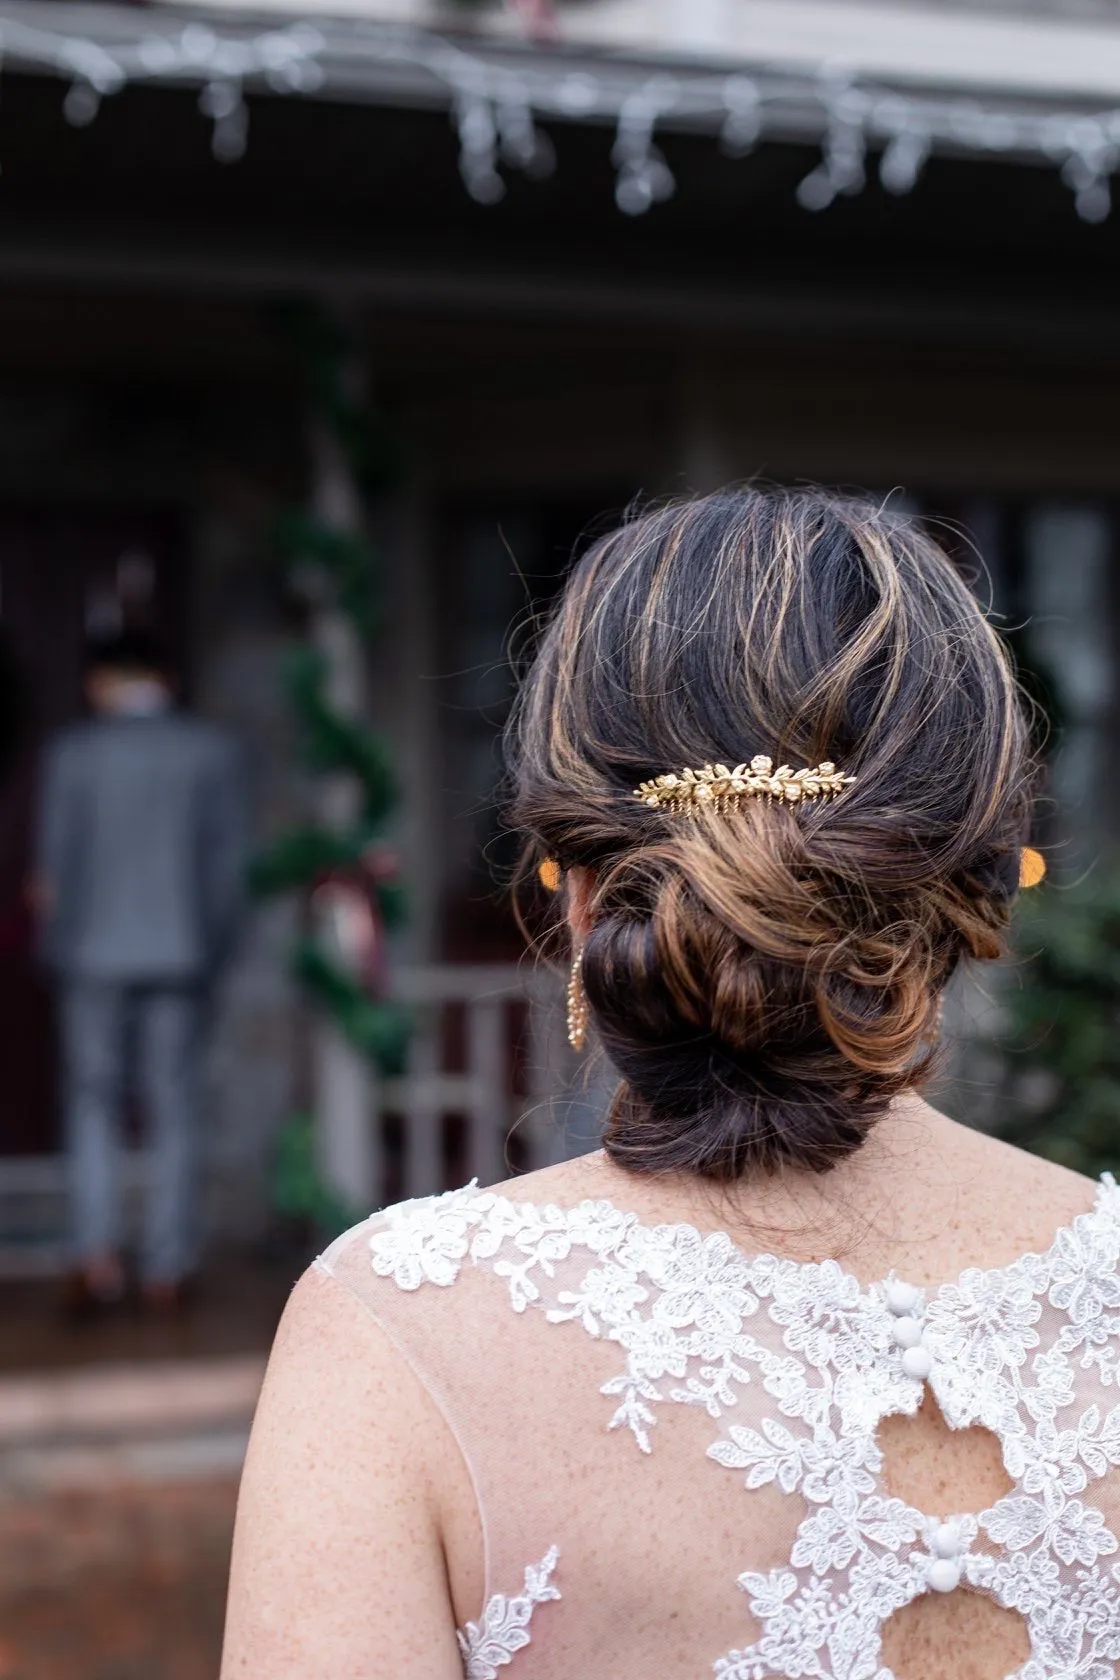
top-left (0, 1477), bottom-right (237, 1680)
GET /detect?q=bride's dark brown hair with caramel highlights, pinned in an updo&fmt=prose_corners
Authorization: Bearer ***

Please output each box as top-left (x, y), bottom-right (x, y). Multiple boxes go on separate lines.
top-left (509, 489), bottom-right (1029, 1179)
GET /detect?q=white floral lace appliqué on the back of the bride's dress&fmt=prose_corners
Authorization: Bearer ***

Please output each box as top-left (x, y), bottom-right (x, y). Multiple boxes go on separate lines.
top-left (369, 1176), bottom-right (1120, 1680)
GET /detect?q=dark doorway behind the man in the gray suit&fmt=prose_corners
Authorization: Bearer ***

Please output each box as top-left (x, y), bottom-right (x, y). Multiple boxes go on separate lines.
top-left (0, 507), bottom-right (186, 1154)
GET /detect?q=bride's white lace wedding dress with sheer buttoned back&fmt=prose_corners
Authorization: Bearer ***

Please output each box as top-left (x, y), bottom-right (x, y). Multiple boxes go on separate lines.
top-left (319, 1178), bottom-right (1120, 1680)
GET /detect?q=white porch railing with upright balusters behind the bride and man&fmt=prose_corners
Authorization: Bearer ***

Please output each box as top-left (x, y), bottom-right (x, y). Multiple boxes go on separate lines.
top-left (0, 963), bottom-right (606, 1277)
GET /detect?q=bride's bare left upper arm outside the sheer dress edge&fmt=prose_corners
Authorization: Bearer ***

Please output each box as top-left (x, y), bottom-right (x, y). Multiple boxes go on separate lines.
top-left (222, 1268), bottom-right (462, 1680)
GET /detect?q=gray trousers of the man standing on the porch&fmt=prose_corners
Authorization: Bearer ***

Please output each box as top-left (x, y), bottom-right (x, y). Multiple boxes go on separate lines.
top-left (60, 979), bottom-right (207, 1282)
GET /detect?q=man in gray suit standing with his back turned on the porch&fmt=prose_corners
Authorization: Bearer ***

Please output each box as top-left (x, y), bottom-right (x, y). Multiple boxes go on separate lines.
top-left (37, 633), bottom-right (247, 1309)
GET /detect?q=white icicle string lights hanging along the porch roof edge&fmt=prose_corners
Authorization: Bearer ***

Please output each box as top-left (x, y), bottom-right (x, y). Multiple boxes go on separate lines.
top-left (0, 0), bottom-right (1120, 222)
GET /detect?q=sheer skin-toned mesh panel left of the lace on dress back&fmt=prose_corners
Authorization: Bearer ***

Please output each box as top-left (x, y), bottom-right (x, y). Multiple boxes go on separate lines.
top-left (329, 1209), bottom-right (803, 1680)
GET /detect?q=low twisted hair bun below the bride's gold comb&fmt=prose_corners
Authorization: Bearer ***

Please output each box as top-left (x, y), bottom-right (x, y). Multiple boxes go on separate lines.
top-left (583, 808), bottom-right (950, 1178)
